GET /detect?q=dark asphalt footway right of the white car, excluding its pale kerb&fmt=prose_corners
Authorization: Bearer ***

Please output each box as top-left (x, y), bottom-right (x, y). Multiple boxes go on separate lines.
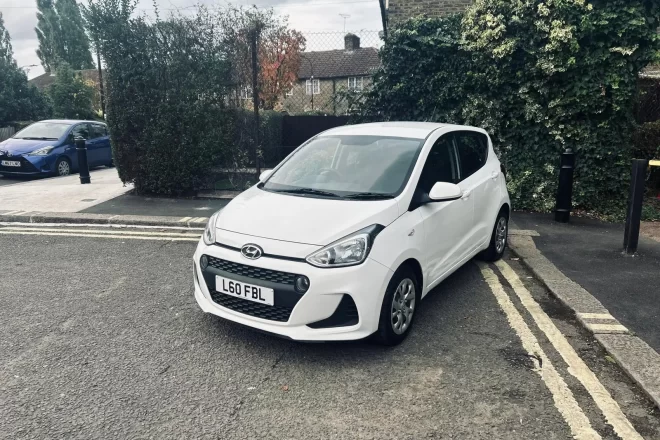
top-left (514, 213), bottom-right (660, 352)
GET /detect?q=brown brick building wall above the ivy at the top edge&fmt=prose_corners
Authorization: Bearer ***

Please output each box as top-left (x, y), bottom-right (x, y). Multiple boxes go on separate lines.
top-left (381, 0), bottom-right (473, 31)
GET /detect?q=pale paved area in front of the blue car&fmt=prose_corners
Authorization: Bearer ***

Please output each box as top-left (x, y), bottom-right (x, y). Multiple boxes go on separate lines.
top-left (0, 168), bottom-right (132, 212)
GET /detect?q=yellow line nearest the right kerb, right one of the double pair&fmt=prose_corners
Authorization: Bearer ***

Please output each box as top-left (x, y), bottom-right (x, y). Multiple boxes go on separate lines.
top-left (495, 261), bottom-right (643, 440)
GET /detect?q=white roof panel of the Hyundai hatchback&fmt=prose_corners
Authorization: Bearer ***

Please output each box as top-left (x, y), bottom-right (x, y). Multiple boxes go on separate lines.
top-left (321, 121), bottom-right (485, 139)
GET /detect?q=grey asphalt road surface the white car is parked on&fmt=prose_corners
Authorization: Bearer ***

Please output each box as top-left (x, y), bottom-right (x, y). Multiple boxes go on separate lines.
top-left (0, 225), bottom-right (660, 440)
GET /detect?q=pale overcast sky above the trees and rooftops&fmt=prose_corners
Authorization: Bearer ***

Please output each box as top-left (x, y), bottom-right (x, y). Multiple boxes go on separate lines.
top-left (0, 0), bottom-right (382, 78)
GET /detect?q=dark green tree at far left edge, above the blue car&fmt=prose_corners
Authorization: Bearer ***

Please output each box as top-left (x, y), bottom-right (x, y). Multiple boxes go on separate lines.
top-left (0, 13), bottom-right (50, 126)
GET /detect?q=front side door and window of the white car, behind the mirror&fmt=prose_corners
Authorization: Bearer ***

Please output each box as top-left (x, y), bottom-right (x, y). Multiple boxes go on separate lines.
top-left (413, 133), bottom-right (474, 287)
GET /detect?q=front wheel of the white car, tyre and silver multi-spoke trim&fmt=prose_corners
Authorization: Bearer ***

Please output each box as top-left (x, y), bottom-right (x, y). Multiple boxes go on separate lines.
top-left (374, 266), bottom-right (422, 346)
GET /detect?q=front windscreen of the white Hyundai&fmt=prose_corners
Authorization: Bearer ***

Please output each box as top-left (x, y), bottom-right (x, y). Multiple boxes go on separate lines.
top-left (262, 135), bottom-right (423, 200)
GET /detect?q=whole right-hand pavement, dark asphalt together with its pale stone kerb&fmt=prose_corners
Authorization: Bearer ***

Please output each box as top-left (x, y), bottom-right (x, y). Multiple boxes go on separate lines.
top-left (510, 213), bottom-right (660, 408)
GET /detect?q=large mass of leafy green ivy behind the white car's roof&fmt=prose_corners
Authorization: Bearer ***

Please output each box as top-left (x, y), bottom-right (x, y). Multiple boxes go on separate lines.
top-left (362, 0), bottom-right (660, 215)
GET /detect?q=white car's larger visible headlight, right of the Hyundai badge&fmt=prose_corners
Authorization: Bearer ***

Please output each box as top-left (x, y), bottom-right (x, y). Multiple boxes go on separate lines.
top-left (306, 225), bottom-right (384, 267)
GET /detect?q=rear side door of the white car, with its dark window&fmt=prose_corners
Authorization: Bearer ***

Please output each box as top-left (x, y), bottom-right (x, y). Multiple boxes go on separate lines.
top-left (454, 131), bottom-right (500, 250)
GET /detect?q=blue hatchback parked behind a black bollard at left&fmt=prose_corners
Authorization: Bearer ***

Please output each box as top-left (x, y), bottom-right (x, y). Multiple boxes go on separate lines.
top-left (0, 120), bottom-right (112, 176)
